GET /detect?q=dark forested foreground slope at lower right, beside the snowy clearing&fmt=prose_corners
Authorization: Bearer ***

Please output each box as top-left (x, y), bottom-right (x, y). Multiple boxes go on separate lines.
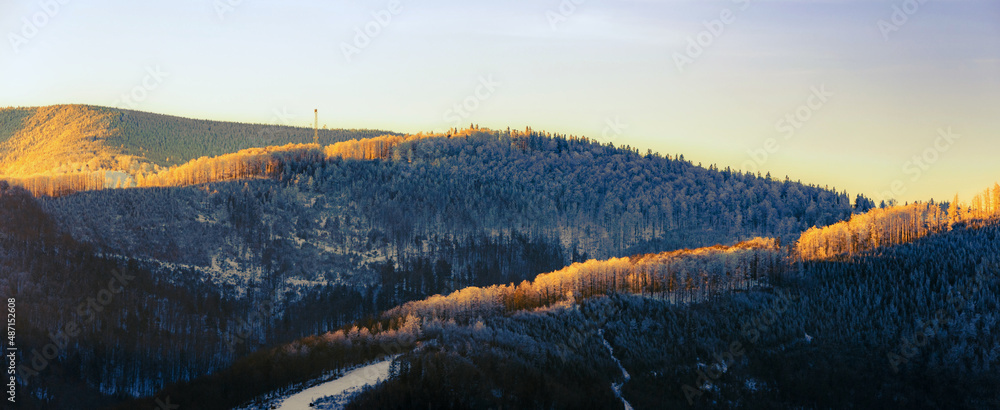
top-left (123, 218), bottom-right (1000, 409)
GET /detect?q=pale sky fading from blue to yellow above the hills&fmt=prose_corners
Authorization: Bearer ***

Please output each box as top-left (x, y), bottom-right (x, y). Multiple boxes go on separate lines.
top-left (0, 0), bottom-right (1000, 203)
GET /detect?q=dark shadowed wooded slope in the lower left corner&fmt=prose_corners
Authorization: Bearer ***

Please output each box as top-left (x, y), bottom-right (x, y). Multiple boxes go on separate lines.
top-left (0, 181), bottom-right (234, 409)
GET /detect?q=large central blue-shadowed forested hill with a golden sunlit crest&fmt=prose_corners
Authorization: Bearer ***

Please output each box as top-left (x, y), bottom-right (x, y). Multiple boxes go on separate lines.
top-left (35, 125), bottom-right (851, 318)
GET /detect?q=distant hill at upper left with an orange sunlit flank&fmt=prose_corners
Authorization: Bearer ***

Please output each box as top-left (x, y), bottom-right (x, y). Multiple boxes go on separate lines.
top-left (0, 105), bottom-right (394, 176)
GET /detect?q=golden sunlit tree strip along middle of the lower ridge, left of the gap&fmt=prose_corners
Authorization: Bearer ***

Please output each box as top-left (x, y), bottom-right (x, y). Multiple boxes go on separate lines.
top-left (385, 238), bottom-right (787, 321)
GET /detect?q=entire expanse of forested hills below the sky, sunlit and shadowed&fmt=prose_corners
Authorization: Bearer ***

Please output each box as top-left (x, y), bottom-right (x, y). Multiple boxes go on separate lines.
top-left (0, 106), bottom-right (1000, 409)
